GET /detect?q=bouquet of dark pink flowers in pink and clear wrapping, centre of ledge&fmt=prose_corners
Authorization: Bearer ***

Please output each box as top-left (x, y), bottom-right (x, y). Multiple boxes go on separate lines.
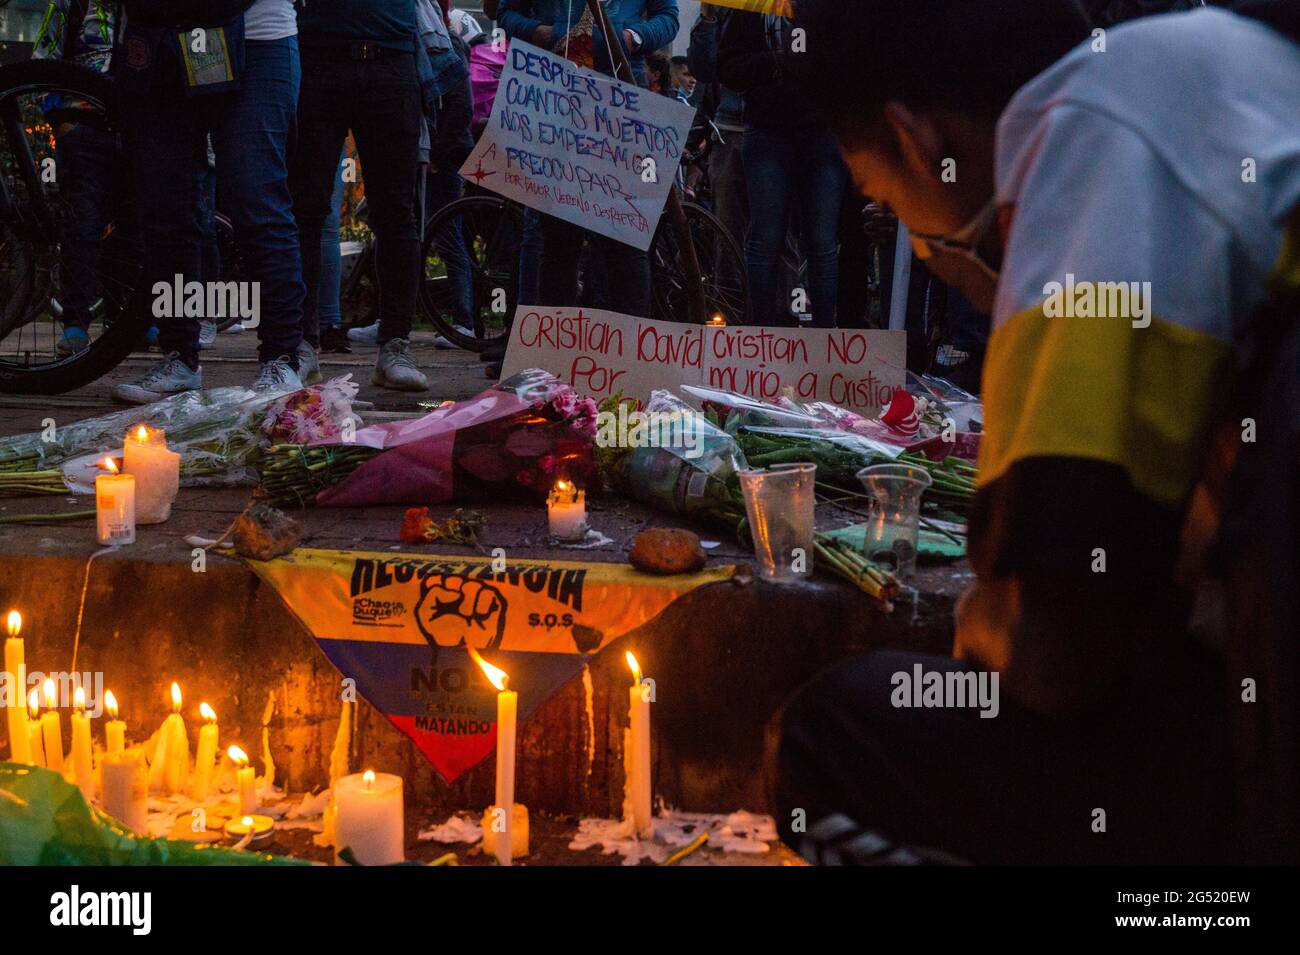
top-left (270, 369), bottom-right (597, 507)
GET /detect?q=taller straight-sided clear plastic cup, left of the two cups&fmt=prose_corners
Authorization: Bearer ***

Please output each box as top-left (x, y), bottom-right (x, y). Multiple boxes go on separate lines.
top-left (737, 464), bottom-right (816, 583)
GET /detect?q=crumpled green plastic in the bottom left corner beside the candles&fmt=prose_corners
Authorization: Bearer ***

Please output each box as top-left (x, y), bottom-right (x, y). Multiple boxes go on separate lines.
top-left (0, 763), bottom-right (309, 865)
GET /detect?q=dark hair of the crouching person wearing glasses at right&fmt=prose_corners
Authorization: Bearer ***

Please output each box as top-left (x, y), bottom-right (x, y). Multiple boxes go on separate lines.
top-left (787, 0), bottom-right (1089, 139)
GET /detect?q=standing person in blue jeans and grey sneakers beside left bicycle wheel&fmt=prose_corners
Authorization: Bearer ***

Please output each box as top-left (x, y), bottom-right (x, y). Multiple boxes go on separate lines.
top-left (112, 0), bottom-right (303, 404)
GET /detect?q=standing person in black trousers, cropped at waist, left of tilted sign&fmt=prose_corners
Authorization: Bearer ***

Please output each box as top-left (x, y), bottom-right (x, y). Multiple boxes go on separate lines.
top-left (290, 0), bottom-right (429, 391)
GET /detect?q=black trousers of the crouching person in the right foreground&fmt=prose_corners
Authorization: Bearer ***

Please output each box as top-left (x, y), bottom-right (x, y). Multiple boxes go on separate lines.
top-left (775, 652), bottom-right (1230, 864)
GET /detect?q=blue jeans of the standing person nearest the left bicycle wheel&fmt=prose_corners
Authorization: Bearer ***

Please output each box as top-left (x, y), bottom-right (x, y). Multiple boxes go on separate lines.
top-left (122, 36), bottom-right (303, 368)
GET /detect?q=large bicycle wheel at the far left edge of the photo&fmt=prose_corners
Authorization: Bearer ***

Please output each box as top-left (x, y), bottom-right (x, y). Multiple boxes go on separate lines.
top-left (0, 60), bottom-right (150, 395)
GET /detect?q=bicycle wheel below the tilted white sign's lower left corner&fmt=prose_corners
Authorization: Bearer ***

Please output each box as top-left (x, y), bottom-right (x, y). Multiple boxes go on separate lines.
top-left (420, 196), bottom-right (524, 352)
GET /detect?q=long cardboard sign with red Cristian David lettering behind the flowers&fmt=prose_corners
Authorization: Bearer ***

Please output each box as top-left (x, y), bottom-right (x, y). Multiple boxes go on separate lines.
top-left (502, 305), bottom-right (906, 414)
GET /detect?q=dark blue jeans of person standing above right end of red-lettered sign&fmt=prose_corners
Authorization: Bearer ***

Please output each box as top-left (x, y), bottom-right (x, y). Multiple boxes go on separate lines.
top-left (742, 126), bottom-right (848, 329)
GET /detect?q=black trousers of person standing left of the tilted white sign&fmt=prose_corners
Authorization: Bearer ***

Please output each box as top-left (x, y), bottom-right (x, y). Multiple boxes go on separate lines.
top-left (290, 42), bottom-right (424, 344)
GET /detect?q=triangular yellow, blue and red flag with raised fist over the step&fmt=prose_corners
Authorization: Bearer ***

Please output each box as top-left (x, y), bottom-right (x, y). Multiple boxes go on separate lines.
top-left (250, 550), bottom-right (732, 782)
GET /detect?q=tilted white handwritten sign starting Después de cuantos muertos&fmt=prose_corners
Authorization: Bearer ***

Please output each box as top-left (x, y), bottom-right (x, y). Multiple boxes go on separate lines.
top-left (460, 40), bottom-right (696, 251)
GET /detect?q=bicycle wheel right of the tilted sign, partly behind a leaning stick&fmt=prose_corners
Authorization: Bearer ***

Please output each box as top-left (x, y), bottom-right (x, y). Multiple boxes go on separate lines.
top-left (650, 203), bottom-right (749, 324)
